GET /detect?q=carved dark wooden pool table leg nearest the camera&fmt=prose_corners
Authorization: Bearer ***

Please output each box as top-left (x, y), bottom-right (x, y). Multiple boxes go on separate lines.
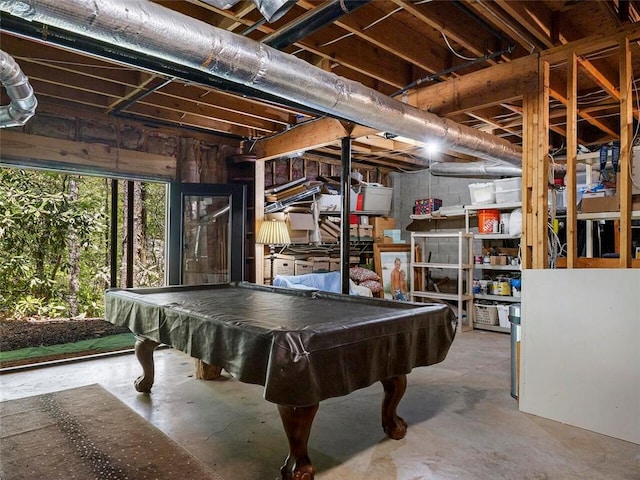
top-left (278, 404), bottom-right (318, 480)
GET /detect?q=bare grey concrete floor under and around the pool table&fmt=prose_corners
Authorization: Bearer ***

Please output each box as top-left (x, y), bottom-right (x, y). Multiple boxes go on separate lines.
top-left (0, 330), bottom-right (640, 480)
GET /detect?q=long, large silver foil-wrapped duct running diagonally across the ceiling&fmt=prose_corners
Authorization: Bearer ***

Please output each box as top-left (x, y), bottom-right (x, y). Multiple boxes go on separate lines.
top-left (0, 0), bottom-right (522, 165)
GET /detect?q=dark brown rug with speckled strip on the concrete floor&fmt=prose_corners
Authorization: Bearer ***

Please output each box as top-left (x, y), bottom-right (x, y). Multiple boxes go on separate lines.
top-left (0, 385), bottom-right (223, 480)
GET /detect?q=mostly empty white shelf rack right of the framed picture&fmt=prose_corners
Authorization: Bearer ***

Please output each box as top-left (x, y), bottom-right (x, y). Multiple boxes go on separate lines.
top-left (410, 232), bottom-right (473, 331)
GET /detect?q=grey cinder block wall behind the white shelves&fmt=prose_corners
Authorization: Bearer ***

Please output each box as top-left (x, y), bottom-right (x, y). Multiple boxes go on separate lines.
top-left (390, 170), bottom-right (490, 263)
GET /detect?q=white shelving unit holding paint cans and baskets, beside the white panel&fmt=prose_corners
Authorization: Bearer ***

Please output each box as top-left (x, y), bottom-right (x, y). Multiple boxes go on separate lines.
top-left (464, 202), bottom-right (521, 333)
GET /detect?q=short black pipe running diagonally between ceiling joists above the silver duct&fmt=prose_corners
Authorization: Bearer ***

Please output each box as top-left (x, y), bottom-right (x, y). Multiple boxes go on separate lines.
top-left (260, 0), bottom-right (370, 50)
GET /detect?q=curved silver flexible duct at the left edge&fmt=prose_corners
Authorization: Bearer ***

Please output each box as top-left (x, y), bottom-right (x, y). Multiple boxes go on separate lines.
top-left (0, 50), bottom-right (38, 128)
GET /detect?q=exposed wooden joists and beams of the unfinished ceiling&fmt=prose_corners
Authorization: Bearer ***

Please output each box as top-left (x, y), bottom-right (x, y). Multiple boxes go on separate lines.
top-left (0, 0), bottom-right (640, 169)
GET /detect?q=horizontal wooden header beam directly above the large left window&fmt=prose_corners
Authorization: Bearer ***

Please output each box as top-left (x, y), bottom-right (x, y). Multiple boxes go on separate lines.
top-left (0, 130), bottom-right (176, 181)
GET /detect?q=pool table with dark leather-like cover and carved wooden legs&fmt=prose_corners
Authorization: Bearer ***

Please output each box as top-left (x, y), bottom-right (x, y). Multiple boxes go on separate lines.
top-left (105, 282), bottom-right (456, 480)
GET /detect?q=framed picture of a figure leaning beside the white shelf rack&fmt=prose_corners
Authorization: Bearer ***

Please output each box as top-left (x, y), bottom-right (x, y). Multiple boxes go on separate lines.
top-left (373, 243), bottom-right (411, 301)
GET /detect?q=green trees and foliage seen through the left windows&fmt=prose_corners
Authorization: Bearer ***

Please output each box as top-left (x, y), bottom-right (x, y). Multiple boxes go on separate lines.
top-left (0, 168), bottom-right (165, 318)
